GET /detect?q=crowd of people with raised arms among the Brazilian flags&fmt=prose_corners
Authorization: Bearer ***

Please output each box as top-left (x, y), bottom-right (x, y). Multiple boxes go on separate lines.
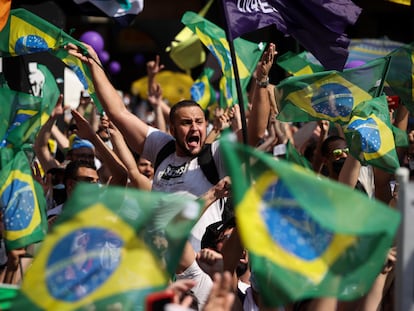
top-left (0, 39), bottom-right (414, 311)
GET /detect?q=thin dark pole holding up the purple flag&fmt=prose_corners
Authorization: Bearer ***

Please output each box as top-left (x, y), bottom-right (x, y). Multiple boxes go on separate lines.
top-left (219, 0), bottom-right (247, 144)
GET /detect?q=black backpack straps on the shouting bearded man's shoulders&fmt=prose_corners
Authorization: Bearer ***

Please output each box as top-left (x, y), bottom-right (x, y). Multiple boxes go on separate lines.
top-left (154, 140), bottom-right (220, 185)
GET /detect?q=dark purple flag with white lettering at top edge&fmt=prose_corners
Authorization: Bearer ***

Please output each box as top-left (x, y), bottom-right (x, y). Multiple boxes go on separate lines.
top-left (223, 0), bottom-right (361, 70)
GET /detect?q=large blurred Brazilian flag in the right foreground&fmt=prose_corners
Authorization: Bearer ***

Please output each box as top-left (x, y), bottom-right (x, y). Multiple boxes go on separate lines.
top-left (220, 136), bottom-right (400, 307)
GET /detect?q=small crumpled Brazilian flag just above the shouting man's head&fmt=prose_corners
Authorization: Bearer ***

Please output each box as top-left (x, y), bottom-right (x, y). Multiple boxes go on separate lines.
top-left (190, 67), bottom-right (216, 110)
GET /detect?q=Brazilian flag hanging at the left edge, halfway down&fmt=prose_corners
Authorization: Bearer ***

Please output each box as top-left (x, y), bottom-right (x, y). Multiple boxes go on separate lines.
top-left (0, 148), bottom-right (47, 250)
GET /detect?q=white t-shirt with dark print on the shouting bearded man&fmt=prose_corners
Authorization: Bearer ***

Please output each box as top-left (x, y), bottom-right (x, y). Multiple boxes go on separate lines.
top-left (142, 127), bottom-right (226, 252)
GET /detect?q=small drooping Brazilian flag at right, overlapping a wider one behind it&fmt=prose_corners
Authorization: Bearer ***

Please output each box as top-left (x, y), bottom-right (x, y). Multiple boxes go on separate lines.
top-left (344, 96), bottom-right (400, 173)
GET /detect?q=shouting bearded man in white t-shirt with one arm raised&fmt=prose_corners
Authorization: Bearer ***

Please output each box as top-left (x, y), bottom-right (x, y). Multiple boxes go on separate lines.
top-left (67, 44), bottom-right (244, 251)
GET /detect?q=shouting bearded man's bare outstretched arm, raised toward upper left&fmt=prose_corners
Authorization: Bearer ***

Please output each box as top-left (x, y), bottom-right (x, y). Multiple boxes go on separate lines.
top-left (66, 43), bottom-right (148, 153)
